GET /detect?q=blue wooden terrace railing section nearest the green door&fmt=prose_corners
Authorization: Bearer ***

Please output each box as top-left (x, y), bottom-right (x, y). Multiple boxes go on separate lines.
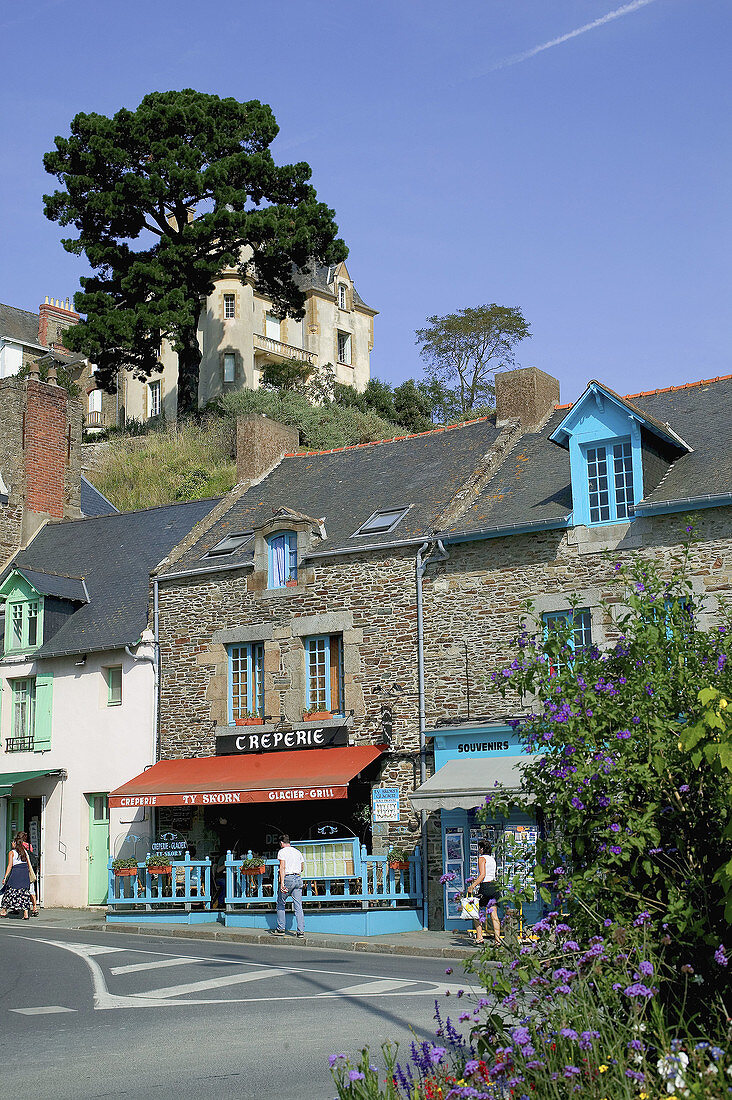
top-left (107, 851), bottom-right (211, 910)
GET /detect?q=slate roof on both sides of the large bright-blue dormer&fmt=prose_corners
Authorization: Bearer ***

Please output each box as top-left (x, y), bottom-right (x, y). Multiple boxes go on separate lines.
top-left (442, 377), bottom-right (732, 534)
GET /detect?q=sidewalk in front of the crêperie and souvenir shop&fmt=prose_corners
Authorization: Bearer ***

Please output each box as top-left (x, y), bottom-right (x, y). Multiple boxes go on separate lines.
top-left (22, 908), bottom-right (474, 959)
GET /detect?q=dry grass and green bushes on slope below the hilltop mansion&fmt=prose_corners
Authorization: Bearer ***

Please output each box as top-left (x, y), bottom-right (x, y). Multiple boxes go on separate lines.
top-left (87, 391), bottom-right (405, 512)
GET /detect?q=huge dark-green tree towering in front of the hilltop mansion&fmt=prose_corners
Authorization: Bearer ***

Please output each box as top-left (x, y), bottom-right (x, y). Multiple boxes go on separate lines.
top-left (44, 88), bottom-right (348, 413)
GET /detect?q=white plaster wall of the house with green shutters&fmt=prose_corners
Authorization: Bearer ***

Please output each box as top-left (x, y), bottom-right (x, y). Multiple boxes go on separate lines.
top-left (0, 649), bottom-right (155, 906)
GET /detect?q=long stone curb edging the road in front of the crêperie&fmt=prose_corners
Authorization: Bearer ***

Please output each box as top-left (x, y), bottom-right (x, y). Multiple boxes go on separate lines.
top-left (28, 919), bottom-right (471, 960)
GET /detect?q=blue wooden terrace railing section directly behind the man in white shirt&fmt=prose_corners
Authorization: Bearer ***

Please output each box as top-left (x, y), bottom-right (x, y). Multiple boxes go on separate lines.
top-left (225, 840), bottom-right (422, 911)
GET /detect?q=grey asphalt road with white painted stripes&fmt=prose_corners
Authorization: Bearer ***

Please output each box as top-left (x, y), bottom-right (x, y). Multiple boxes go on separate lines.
top-left (0, 920), bottom-right (465, 1100)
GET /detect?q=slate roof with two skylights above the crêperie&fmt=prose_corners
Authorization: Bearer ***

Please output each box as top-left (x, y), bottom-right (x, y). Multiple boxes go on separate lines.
top-left (172, 417), bottom-right (501, 571)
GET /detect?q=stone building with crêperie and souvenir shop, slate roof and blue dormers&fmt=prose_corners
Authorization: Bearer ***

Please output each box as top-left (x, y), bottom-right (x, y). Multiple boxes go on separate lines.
top-left (113, 369), bottom-right (732, 926)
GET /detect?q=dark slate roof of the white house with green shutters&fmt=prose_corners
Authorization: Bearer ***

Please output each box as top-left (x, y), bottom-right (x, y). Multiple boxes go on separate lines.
top-left (1, 498), bottom-right (218, 657)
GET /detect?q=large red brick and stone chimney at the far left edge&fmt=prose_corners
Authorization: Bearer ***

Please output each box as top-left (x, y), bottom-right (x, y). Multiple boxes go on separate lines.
top-left (0, 377), bottom-right (83, 567)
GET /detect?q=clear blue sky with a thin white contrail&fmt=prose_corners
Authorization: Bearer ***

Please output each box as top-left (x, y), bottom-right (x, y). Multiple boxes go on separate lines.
top-left (0, 0), bottom-right (732, 400)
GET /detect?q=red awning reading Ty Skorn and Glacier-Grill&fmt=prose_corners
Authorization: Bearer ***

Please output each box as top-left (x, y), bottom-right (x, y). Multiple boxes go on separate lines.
top-left (109, 745), bottom-right (383, 806)
